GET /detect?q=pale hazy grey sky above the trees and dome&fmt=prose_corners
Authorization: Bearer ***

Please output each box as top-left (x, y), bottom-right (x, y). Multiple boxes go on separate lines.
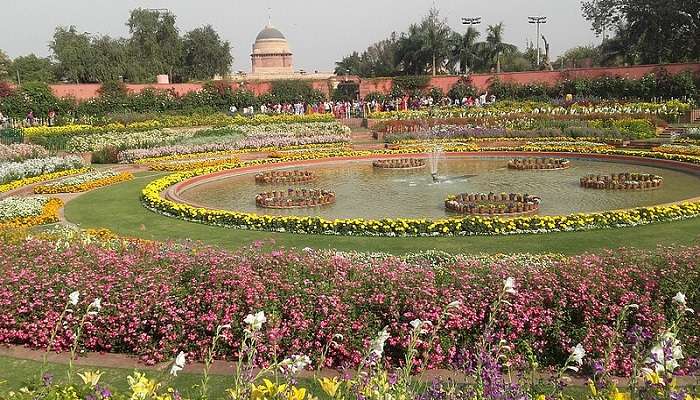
top-left (0, 0), bottom-right (599, 71)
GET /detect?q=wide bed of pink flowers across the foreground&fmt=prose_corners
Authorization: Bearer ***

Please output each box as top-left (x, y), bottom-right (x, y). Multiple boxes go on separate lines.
top-left (0, 240), bottom-right (700, 370)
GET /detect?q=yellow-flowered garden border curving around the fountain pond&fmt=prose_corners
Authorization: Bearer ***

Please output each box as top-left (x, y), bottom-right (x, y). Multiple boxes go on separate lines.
top-left (141, 150), bottom-right (700, 237)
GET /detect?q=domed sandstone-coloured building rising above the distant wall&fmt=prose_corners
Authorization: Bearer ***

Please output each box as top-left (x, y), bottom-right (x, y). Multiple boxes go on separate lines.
top-left (250, 23), bottom-right (294, 75)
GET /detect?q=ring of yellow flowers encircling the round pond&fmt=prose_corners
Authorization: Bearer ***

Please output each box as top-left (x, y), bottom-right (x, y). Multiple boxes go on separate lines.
top-left (141, 146), bottom-right (700, 236)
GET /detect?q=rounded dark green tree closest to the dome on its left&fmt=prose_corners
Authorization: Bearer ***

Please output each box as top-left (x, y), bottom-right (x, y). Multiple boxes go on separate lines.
top-left (183, 25), bottom-right (233, 80)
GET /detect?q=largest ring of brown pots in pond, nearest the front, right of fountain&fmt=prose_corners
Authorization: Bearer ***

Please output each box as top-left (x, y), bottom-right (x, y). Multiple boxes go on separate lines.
top-left (445, 193), bottom-right (540, 216)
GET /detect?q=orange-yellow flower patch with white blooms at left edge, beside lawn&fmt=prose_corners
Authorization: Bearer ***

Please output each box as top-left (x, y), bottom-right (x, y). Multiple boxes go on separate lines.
top-left (0, 197), bottom-right (63, 229)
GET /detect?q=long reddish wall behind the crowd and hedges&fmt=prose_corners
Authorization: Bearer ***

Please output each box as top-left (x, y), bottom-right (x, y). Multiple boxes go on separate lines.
top-left (45, 63), bottom-right (700, 101)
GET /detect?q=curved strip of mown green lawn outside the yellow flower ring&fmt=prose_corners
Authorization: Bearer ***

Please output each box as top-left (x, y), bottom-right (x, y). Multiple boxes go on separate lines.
top-left (65, 173), bottom-right (700, 254)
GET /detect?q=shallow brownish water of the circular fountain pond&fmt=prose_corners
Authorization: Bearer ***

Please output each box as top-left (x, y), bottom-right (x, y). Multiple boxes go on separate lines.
top-left (178, 156), bottom-right (700, 219)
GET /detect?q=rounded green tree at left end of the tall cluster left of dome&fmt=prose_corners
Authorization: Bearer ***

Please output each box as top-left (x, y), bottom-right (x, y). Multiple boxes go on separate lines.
top-left (49, 26), bottom-right (95, 83)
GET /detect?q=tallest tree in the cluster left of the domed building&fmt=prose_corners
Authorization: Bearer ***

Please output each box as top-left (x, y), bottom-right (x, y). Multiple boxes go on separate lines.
top-left (127, 8), bottom-right (183, 80)
